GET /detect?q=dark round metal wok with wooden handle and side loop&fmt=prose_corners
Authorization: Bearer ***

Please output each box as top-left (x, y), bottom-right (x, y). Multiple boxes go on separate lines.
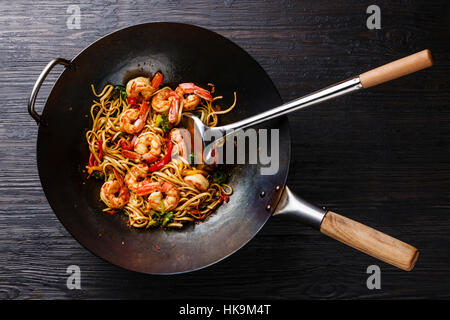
top-left (28, 23), bottom-right (426, 274)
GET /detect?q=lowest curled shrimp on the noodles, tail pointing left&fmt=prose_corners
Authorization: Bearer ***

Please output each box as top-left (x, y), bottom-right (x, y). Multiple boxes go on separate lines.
top-left (137, 180), bottom-right (180, 212)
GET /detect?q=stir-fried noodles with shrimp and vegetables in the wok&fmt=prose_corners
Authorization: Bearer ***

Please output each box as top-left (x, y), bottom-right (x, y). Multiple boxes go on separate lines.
top-left (86, 73), bottom-right (236, 228)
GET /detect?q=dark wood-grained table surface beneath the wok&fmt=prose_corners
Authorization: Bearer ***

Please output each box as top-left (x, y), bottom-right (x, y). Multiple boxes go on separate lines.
top-left (0, 0), bottom-right (450, 299)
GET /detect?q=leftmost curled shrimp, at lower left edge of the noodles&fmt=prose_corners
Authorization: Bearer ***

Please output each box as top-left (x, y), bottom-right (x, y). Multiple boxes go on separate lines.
top-left (100, 169), bottom-right (130, 209)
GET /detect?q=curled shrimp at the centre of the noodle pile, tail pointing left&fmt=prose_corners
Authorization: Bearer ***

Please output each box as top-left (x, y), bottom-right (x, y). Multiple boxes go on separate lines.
top-left (122, 132), bottom-right (161, 163)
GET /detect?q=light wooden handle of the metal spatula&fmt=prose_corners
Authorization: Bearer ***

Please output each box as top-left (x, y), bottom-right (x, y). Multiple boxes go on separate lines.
top-left (359, 49), bottom-right (433, 88)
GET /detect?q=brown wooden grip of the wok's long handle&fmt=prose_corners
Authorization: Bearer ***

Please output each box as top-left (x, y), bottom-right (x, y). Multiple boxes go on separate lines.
top-left (320, 211), bottom-right (419, 271)
